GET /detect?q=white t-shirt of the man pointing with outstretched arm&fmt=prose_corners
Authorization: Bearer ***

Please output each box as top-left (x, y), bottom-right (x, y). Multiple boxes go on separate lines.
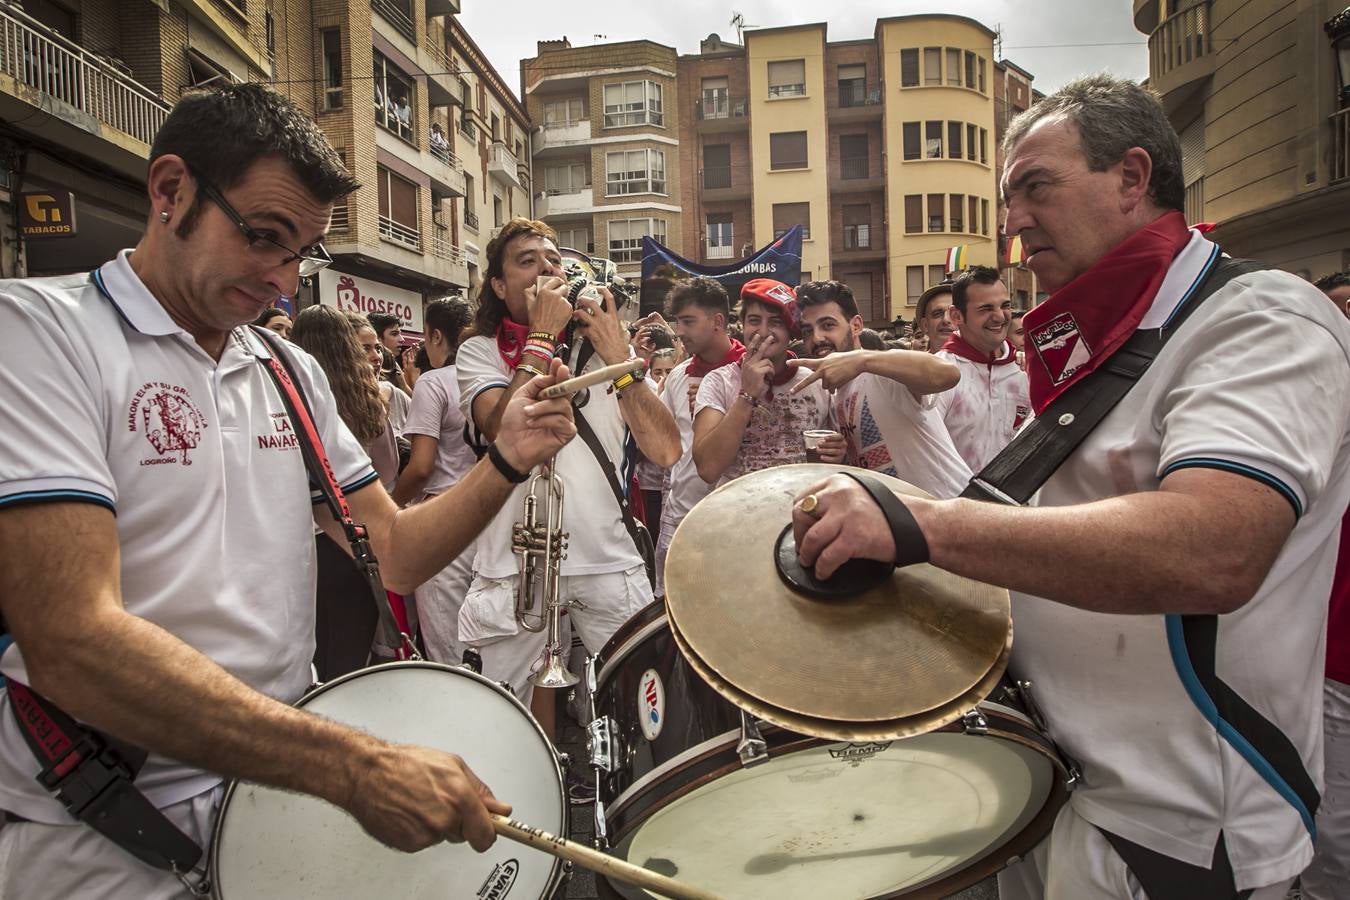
top-left (834, 372), bottom-right (971, 499)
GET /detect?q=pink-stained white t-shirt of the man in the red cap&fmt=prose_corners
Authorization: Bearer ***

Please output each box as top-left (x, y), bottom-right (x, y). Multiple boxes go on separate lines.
top-left (694, 366), bottom-right (833, 484)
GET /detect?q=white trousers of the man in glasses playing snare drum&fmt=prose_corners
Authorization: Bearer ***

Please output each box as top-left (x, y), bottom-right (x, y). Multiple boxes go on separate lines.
top-left (0, 787), bottom-right (224, 900)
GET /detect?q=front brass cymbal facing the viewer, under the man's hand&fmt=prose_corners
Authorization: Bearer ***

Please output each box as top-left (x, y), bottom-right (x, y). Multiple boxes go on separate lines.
top-left (666, 464), bottom-right (1013, 730)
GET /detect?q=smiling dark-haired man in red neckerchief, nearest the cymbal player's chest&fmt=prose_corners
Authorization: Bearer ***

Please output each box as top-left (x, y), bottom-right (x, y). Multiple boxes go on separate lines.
top-left (937, 266), bottom-right (1031, 472)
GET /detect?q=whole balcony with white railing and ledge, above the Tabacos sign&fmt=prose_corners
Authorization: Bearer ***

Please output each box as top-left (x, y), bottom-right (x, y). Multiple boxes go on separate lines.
top-left (0, 7), bottom-right (169, 179)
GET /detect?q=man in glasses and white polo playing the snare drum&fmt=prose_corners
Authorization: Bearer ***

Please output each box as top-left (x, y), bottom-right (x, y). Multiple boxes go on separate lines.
top-left (0, 84), bottom-right (574, 900)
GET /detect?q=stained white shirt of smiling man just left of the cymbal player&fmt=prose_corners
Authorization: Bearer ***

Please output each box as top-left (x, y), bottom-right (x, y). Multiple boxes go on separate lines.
top-left (936, 343), bottom-right (1031, 472)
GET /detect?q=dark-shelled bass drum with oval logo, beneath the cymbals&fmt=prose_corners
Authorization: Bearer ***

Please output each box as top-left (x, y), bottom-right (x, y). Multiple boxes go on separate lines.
top-left (595, 602), bottom-right (1069, 900)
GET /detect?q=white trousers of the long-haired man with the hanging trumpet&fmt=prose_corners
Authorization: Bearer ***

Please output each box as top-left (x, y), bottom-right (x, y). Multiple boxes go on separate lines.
top-left (459, 563), bottom-right (652, 706)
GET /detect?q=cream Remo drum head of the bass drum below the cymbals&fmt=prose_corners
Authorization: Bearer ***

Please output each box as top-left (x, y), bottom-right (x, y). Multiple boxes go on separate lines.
top-left (613, 730), bottom-right (1057, 900)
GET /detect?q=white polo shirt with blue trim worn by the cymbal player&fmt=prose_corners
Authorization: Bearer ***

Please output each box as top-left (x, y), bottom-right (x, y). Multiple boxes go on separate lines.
top-left (1013, 233), bottom-right (1350, 891)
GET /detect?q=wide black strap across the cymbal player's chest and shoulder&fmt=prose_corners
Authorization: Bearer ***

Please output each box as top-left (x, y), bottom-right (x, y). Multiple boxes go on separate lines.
top-left (961, 248), bottom-right (1269, 506)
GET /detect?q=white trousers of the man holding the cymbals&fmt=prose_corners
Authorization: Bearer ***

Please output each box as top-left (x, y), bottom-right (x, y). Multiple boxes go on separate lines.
top-left (999, 803), bottom-right (1289, 900)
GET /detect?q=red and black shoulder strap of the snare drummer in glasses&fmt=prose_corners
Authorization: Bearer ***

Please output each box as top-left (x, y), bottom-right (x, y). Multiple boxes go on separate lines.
top-left (254, 327), bottom-right (420, 658)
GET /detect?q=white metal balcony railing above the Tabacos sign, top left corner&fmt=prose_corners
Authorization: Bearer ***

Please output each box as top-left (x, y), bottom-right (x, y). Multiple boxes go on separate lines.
top-left (0, 7), bottom-right (169, 144)
